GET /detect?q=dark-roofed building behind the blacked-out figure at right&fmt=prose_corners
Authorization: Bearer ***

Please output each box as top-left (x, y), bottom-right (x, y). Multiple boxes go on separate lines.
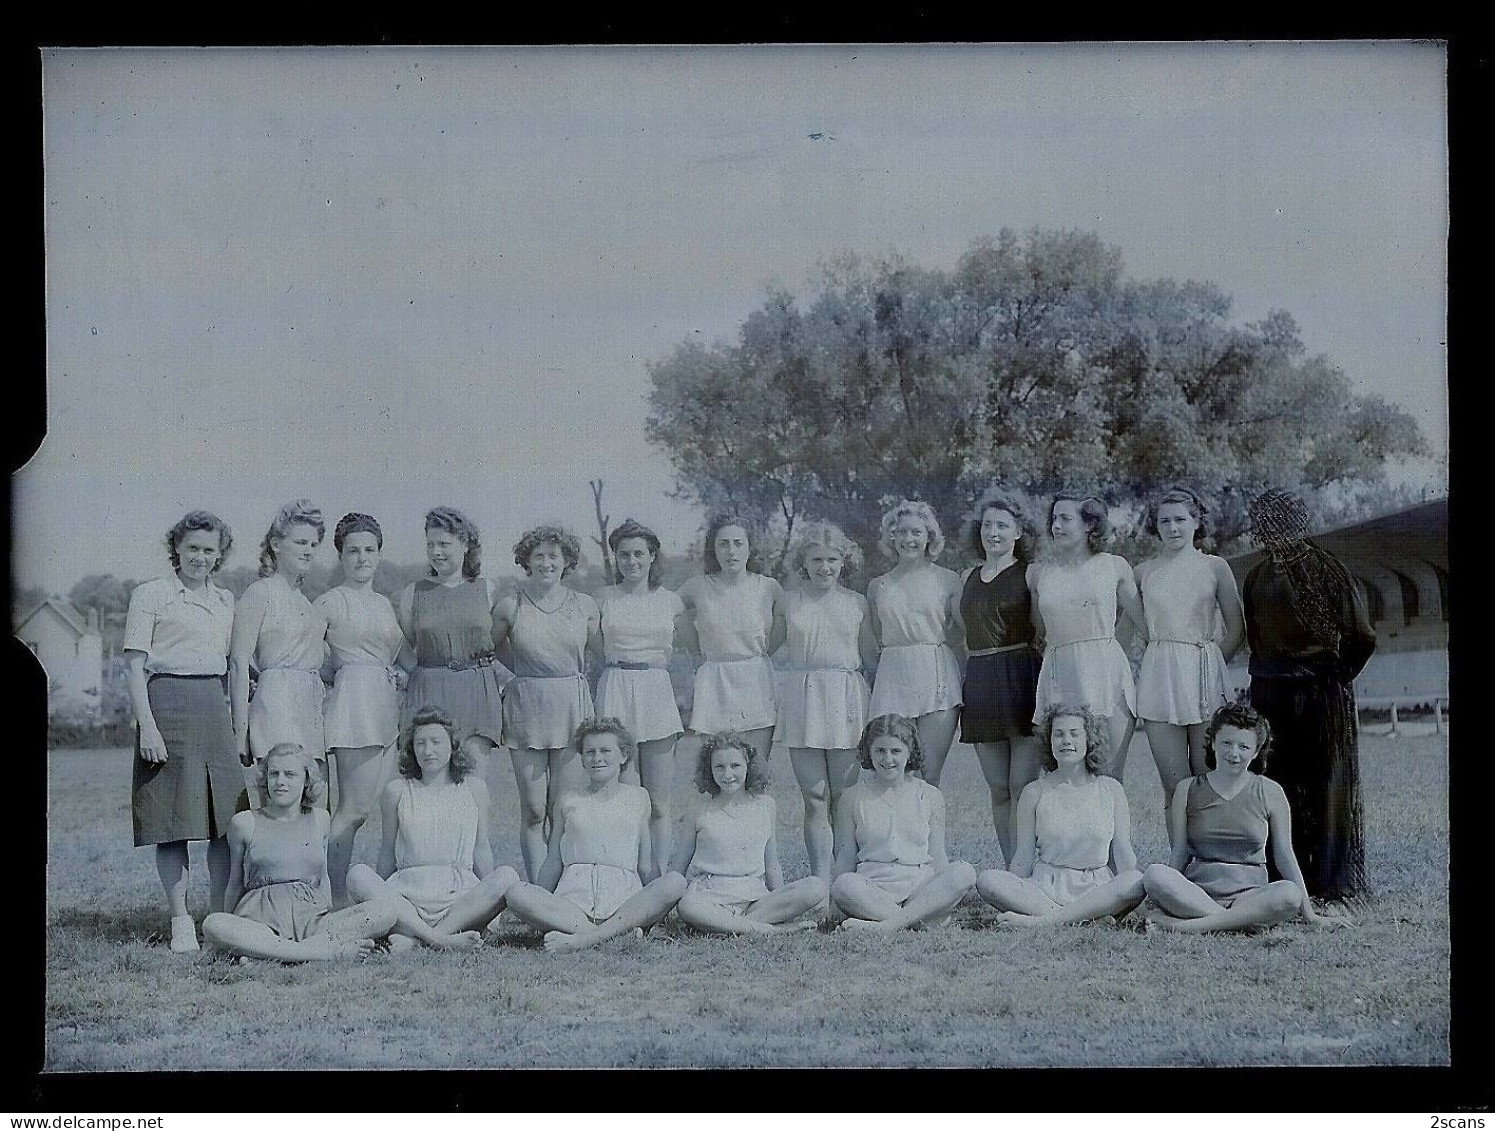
top-left (1229, 499), bottom-right (1449, 707)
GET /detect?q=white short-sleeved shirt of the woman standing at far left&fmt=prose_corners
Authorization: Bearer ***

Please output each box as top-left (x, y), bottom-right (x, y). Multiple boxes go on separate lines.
top-left (124, 575), bottom-right (233, 675)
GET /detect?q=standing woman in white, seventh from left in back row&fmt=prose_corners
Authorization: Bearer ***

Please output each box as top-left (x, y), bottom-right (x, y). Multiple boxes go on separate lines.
top-left (680, 514), bottom-right (785, 759)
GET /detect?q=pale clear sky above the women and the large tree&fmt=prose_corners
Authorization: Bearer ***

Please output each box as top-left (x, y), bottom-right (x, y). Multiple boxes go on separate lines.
top-left (12, 43), bottom-right (1447, 593)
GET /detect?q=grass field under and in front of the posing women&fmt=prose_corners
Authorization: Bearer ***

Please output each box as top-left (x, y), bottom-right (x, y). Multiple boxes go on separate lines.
top-left (46, 728), bottom-right (1449, 1071)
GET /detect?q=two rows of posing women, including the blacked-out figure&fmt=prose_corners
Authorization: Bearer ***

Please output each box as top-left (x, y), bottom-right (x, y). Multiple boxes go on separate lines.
top-left (124, 489), bottom-right (1374, 956)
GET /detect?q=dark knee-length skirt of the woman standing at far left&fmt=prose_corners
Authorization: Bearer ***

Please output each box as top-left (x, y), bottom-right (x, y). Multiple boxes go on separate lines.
top-left (130, 675), bottom-right (244, 846)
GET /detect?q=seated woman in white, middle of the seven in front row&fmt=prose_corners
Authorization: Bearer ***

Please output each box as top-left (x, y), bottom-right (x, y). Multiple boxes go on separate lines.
top-left (674, 732), bottom-right (830, 935)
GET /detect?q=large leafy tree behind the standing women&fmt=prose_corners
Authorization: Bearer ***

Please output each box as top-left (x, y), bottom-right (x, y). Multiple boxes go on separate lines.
top-left (647, 230), bottom-right (1426, 567)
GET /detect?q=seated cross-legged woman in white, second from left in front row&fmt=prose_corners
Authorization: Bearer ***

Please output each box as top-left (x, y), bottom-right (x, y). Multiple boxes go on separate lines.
top-left (348, 707), bottom-right (519, 949)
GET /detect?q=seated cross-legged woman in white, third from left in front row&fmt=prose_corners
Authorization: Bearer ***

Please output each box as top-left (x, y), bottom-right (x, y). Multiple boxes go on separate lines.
top-left (508, 719), bottom-right (685, 952)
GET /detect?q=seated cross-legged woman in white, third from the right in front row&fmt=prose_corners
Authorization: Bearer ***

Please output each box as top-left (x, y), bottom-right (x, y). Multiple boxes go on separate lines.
top-left (831, 714), bottom-right (976, 931)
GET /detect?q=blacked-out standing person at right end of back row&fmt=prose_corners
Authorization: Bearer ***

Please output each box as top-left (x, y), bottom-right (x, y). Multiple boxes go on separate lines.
top-left (1242, 490), bottom-right (1375, 901)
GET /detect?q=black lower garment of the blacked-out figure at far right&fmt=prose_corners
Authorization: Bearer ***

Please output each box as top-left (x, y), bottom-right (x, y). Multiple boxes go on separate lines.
top-left (1251, 675), bottom-right (1365, 899)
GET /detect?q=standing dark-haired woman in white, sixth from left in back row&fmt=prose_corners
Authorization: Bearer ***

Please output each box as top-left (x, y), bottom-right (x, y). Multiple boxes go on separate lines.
top-left (597, 518), bottom-right (685, 876)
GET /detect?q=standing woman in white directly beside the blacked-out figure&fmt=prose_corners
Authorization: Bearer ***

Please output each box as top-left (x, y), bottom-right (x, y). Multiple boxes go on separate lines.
top-left (1135, 487), bottom-right (1245, 813)
